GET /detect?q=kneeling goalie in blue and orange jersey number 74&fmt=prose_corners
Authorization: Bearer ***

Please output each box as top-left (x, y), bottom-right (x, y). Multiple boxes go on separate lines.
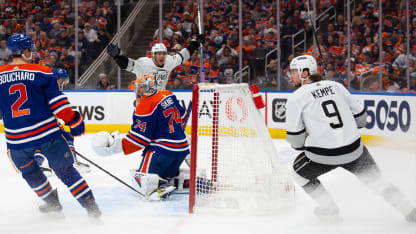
top-left (93, 74), bottom-right (189, 200)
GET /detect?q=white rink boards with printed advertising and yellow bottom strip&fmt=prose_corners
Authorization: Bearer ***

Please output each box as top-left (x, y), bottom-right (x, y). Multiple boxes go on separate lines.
top-left (0, 91), bottom-right (416, 145)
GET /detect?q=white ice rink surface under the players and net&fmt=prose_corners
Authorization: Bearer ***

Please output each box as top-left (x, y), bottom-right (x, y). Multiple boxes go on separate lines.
top-left (0, 134), bottom-right (416, 234)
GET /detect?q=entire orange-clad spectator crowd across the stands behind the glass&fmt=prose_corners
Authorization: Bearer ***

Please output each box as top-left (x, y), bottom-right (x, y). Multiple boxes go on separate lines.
top-left (0, 0), bottom-right (416, 92)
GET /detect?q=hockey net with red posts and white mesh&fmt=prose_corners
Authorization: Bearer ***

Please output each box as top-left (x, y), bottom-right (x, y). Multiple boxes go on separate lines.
top-left (189, 84), bottom-right (294, 214)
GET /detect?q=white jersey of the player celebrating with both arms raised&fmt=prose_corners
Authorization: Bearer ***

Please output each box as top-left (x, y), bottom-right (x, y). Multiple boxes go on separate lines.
top-left (126, 48), bottom-right (190, 90)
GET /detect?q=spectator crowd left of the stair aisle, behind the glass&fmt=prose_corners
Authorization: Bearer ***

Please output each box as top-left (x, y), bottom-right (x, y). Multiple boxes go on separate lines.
top-left (0, 0), bottom-right (115, 86)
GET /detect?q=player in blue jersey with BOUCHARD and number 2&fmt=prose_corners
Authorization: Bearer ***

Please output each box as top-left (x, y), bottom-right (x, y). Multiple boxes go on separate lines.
top-left (0, 34), bottom-right (101, 217)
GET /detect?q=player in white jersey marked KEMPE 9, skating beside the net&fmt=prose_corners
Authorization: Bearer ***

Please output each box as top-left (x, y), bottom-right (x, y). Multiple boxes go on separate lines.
top-left (286, 55), bottom-right (416, 222)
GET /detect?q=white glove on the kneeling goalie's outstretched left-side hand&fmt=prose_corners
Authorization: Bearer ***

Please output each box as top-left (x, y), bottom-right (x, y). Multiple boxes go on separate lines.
top-left (92, 131), bottom-right (123, 156)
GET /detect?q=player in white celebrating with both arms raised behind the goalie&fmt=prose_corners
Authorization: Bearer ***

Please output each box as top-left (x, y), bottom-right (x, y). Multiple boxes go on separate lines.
top-left (107, 34), bottom-right (205, 90)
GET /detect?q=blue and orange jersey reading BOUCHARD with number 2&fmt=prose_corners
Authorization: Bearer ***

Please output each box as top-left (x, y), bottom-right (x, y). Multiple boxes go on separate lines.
top-left (0, 64), bottom-right (75, 149)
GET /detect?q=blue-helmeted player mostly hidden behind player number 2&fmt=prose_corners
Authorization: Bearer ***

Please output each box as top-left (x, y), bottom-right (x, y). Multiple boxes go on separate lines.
top-left (35, 68), bottom-right (91, 176)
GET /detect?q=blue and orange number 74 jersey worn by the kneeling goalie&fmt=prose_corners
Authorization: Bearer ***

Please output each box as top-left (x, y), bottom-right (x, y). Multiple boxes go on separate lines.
top-left (123, 90), bottom-right (189, 156)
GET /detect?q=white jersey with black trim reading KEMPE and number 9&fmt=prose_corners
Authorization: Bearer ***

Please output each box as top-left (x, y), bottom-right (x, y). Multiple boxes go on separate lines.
top-left (286, 80), bottom-right (366, 165)
